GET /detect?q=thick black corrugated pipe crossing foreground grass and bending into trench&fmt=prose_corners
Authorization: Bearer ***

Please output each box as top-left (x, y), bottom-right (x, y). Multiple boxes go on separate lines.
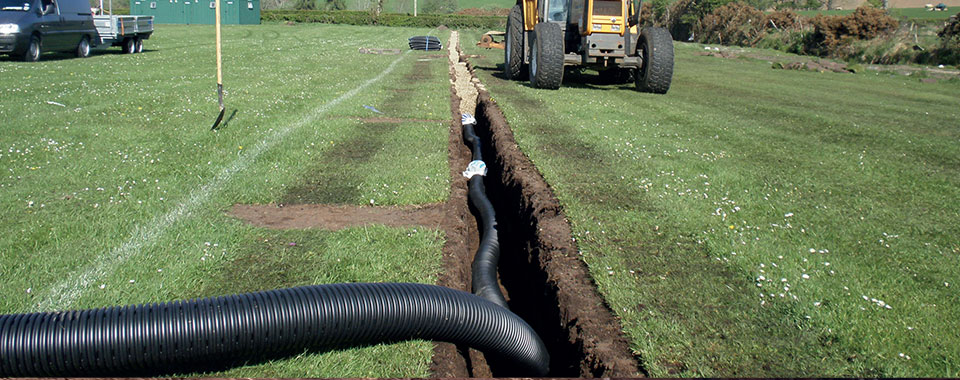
top-left (0, 283), bottom-right (550, 377)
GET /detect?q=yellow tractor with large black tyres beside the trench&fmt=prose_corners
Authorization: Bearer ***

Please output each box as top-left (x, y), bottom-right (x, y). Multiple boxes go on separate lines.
top-left (503, 0), bottom-right (673, 94)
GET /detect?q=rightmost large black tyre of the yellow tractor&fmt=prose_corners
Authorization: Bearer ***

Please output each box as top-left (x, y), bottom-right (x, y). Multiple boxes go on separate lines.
top-left (637, 27), bottom-right (673, 94)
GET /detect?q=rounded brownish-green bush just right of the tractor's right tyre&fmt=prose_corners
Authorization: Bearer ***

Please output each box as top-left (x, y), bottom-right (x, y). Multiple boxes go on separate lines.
top-left (696, 2), bottom-right (765, 46)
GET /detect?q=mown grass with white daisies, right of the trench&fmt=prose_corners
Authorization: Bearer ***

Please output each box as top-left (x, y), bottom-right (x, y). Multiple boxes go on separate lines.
top-left (463, 34), bottom-right (960, 377)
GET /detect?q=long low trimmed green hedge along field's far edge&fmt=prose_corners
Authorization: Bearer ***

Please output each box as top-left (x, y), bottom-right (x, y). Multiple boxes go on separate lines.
top-left (260, 10), bottom-right (507, 29)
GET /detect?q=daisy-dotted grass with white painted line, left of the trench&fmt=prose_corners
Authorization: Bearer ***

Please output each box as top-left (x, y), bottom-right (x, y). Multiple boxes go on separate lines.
top-left (0, 24), bottom-right (449, 377)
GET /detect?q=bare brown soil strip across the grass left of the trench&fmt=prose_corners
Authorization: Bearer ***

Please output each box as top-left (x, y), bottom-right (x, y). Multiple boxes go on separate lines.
top-left (230, 204), bottom-right (443, 230)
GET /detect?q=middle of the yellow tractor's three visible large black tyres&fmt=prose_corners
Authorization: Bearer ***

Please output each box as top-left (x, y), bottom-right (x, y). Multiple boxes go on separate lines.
top-left (530, 22), bottom-right (563, 90)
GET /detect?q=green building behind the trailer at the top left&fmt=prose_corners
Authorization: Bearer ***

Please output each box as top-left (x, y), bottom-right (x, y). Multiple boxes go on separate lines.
top-left (130, 0), bottom-right (260, 24)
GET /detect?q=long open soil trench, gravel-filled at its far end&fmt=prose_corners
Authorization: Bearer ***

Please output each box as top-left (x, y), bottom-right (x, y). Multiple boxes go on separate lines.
top-left (432, 32), bottom-right (643, 377)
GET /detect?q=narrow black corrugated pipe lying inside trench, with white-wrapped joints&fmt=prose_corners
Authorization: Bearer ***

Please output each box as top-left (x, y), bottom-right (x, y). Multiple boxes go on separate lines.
top-left (461, 114), bottom-right (508, 308)
